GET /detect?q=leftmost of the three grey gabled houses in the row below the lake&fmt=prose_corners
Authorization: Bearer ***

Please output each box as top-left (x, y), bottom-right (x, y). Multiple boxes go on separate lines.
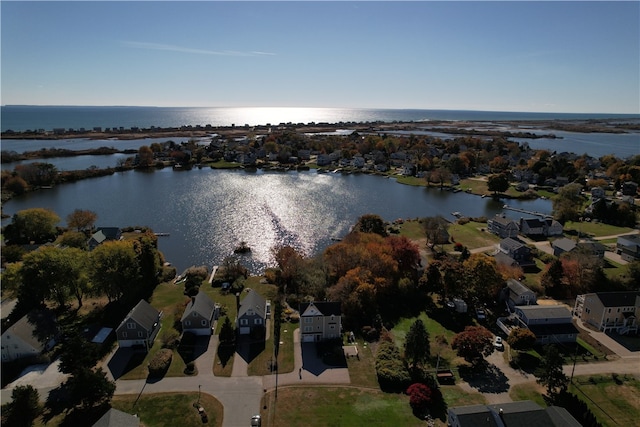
top-left (116, 300), bottom-right (162, 351)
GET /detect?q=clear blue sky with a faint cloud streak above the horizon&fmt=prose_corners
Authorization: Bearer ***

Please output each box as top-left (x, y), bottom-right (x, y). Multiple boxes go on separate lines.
top-left (0, 1), bottom-right (640, 113)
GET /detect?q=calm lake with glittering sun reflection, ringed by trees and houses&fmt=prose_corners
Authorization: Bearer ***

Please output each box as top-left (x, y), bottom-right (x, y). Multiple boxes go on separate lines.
top-left (3, 168), bottom-right (551, 273)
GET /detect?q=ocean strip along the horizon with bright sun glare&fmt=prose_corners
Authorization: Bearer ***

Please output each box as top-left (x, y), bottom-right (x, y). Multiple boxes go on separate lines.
top-left (0, 105), bottom-right (640, 132)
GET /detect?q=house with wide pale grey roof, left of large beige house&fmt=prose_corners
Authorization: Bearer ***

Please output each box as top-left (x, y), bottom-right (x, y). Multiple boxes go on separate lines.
top-left (514, 305), bottom-right (578, 344)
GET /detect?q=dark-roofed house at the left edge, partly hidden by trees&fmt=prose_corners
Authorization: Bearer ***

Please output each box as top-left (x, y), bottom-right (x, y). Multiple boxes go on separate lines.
top-left (0, 311), bottom-right (56, 362)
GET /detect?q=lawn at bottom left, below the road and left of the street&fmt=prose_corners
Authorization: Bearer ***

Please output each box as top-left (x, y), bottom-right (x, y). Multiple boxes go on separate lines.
top-left (111, 392), bottom-right (223, 427)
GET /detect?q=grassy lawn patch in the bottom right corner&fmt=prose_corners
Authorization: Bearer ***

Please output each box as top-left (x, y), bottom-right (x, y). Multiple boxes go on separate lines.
top-left (569, 375), bottom-right (640, 427)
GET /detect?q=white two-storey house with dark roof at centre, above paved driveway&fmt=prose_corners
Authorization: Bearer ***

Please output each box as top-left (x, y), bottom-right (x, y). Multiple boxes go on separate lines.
top-left (300, 301), bottom-right (342, 342)
